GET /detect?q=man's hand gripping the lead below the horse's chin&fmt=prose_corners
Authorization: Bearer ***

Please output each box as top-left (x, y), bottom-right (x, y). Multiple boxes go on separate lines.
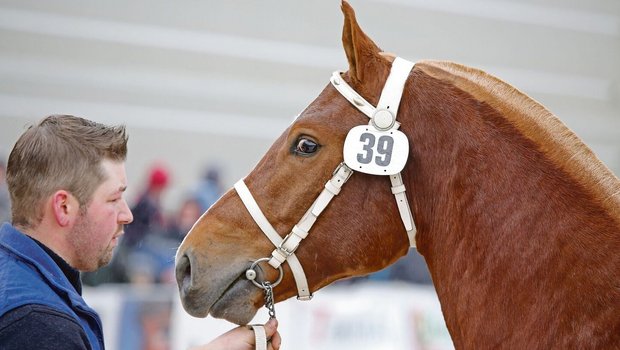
top-left (191, 318), bottom-right (282, 350)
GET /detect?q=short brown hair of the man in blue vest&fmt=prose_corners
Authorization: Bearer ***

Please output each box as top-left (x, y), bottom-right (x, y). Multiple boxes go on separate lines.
top-left (6, 115), bottom-right (127, 227)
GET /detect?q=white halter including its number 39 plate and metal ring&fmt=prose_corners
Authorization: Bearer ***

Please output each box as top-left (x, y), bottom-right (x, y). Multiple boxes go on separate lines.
top-left (234, 57), bottom-right (416, 300)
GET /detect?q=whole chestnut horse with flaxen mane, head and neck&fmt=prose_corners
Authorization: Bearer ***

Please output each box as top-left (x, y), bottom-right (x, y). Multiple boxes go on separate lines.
top-left (176, 1), bottom-right (620, 349)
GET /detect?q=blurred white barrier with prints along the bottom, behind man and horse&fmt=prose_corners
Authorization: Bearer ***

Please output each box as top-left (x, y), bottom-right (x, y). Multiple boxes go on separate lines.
top-left (85, 282), bottom-right (453, 350)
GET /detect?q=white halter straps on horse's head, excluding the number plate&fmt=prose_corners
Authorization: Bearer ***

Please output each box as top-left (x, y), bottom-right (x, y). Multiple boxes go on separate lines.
top-left (234, 57), bottom-right (416, 300)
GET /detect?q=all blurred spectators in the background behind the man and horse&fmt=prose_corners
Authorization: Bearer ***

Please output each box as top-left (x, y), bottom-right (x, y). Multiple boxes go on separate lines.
top-left (0, 159), bottom-right (431, 286)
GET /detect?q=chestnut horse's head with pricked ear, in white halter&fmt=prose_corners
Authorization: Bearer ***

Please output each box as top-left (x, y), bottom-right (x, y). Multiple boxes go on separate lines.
top-left (177, 2), bottom-right (409, 324)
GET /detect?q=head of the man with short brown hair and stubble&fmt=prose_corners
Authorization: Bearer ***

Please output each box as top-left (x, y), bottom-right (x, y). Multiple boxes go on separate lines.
top-left (7, 115), bottom-right (133, 271)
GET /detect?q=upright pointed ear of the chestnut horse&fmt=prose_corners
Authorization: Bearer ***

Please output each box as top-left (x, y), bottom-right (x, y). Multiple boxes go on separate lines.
top-left (340, 0), bottom-right (381, 82)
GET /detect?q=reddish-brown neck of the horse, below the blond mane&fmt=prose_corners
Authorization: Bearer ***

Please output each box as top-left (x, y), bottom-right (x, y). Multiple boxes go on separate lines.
top-left (401, 65), bottom-right (620, 348)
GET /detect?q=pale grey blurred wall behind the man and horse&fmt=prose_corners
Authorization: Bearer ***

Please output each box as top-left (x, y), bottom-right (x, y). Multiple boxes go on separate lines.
top-left (0, 0), bottom-right (620, 211)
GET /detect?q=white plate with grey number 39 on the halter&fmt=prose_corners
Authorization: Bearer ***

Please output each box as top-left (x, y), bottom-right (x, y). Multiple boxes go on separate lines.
top-left (343, 125), bottom-right (409, 175)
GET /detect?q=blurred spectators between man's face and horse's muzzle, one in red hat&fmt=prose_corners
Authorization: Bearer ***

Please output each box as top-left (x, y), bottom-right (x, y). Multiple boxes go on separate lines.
top-left (82, 163), bottom-right (223, 285)
